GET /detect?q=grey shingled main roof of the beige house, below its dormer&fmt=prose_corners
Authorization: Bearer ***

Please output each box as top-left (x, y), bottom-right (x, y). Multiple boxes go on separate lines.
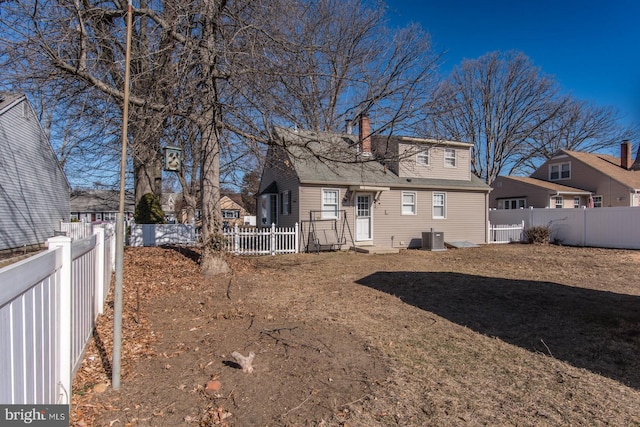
top-left (274, 127), bottom-right (491, 192)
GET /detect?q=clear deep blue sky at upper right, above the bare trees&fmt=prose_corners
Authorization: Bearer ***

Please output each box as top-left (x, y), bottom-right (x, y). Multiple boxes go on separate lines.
top-left (386, 0), bottom-right (640, 124)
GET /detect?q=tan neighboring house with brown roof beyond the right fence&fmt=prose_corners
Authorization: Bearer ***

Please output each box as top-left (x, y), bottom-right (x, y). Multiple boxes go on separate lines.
top-left (489, 141), bottom-right (640, 209)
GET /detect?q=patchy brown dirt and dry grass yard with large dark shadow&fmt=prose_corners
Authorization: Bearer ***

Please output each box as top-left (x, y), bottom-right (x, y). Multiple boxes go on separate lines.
top-left (72, 245), bottom-right (640, 427)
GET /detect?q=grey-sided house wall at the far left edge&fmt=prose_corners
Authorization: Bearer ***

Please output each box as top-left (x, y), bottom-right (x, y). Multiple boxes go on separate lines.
top-left (0, 93), bottom-right (70, 250)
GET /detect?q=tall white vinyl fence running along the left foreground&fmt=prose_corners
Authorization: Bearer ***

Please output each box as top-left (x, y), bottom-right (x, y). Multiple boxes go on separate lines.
top-left (0, 228), bottom-right (115, 404)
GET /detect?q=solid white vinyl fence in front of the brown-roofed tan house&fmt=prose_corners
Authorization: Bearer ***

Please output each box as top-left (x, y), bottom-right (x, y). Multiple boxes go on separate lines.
top-left (489, 207), bottom-right (640, 249)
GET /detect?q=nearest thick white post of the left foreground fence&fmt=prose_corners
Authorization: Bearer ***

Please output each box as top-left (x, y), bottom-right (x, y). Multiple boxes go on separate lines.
top-left (47, 236), bottom-right (73, 404)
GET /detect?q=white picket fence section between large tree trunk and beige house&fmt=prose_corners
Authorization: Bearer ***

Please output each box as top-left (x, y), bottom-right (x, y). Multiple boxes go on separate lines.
top-left (223, 222), bottom-right (300, 255)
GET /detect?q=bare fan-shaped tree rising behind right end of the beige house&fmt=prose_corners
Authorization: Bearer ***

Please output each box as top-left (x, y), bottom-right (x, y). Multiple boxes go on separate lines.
top-left (431, 51), bottom-right (565, 183)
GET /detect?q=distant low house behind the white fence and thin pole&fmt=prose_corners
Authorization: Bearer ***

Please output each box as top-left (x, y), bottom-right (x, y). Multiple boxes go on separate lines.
top-left (71, 190), bottom-right (135, 222)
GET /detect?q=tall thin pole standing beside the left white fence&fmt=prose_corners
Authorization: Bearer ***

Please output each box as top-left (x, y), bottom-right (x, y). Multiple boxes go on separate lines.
top-left (111, 0), bottom-right (133, 390)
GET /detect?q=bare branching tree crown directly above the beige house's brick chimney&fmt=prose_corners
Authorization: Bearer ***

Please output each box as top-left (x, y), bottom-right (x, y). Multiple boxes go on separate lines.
top-left (243, 0), bottom-right (440, 136)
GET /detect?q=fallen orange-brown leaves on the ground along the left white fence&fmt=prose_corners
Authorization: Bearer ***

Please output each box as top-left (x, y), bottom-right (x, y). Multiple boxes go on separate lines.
top-left (70, 248), bottom-right (215, 427)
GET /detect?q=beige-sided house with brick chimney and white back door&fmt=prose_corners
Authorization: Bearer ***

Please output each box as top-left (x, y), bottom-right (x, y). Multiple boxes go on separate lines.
top-left (257, 117), bottom-right (491, 252)
